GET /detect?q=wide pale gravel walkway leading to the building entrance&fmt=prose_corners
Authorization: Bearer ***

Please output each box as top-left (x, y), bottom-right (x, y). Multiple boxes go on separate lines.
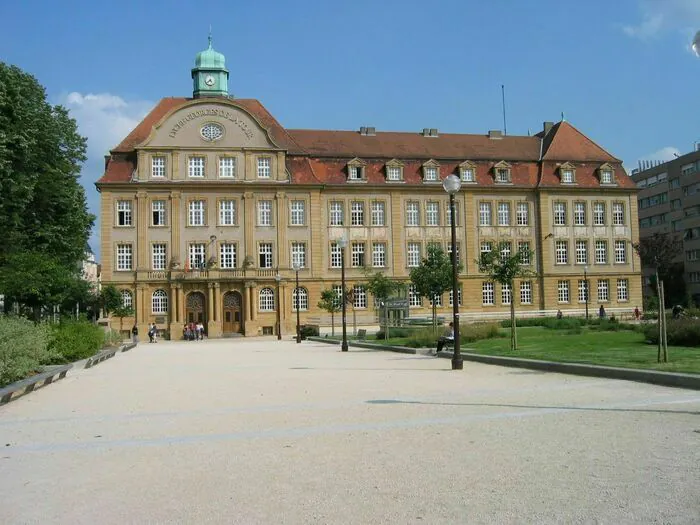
top-left (0, 338), bottom-right (700, 524)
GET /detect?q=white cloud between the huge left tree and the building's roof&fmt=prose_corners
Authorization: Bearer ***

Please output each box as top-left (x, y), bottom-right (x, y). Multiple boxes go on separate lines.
top-left (58, 92), bottom-right (153, 257)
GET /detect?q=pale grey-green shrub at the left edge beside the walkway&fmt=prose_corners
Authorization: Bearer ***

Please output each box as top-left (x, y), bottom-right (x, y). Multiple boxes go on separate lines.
top-left (0, 316), bottom-right (51, 387)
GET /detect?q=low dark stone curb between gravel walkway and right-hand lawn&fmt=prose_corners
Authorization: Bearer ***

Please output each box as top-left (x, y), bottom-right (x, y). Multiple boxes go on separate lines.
top-left (309, 337), bottom-right (700, 390)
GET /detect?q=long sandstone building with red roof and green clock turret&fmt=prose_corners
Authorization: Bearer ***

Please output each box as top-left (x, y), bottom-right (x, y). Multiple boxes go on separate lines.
top-left (97, 41), bottom-right (641, 337)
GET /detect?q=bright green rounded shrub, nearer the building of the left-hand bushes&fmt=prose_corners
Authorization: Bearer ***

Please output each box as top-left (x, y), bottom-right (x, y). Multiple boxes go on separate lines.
top-left (49, 321), bottom-right (105, 363)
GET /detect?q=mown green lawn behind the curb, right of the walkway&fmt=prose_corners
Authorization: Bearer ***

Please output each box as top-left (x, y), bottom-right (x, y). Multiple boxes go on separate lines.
top-left (368, 327), bottom-right (700, 374)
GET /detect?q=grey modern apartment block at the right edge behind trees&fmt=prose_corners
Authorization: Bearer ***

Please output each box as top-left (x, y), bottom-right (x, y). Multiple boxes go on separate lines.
top-left (632, 144), bottom-right (700, 303)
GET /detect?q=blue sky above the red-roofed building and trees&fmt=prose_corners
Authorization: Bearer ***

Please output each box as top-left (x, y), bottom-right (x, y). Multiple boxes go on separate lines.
top-left (0, 0), bottom-right (700, 251)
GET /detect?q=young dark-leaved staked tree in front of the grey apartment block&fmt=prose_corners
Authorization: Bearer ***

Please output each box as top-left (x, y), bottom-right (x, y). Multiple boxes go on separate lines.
top-left (633, 232), bottom-right (683, 363)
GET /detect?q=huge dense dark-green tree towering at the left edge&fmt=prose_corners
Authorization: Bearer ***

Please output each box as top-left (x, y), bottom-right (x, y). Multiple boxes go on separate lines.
top-left (0, 62), bottom-right (94, 315)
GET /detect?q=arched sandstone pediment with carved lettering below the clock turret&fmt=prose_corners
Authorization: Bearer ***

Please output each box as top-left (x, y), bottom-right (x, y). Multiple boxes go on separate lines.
top-left (138, 99), bottom-right (279, 149)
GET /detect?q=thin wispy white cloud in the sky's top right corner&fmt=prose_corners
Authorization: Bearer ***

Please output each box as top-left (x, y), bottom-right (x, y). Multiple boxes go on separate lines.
top-left (622, 0), bottom-right (700, 39)
